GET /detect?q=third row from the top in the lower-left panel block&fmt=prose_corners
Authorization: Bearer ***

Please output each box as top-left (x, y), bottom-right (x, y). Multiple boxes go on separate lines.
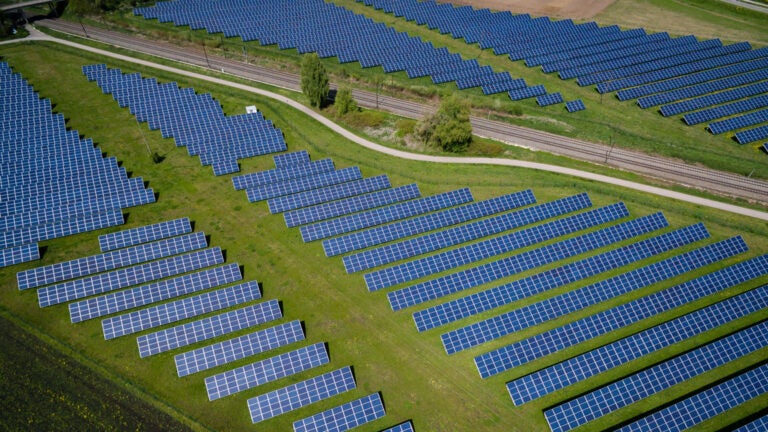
top-left (37, 247), bottom-right (224, 307)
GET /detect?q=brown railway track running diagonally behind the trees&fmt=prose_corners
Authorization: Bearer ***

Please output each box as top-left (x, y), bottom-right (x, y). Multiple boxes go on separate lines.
top-left (37, 20), bottom-right (768, 205)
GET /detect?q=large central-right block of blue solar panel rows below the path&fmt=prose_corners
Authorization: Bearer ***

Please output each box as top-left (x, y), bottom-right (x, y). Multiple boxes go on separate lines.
top-left (233, 145), bottom-right (768, 430)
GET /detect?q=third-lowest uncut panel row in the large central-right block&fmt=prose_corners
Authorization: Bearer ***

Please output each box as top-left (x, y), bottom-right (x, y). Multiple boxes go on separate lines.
top-left (387, 209), bottom-right (667, 310)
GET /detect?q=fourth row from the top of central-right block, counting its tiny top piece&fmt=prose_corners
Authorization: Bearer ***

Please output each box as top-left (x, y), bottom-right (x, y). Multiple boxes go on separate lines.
top-left (267, 175), bottom-right (391, 214)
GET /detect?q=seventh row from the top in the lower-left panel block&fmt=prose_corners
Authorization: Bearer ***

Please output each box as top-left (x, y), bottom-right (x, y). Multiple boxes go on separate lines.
top-left (174, 320), bottom-right (304, 377)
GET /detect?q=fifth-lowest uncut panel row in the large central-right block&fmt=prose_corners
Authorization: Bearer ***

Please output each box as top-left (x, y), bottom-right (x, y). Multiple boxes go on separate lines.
top-left (343, 194), bottom-right (592, 273)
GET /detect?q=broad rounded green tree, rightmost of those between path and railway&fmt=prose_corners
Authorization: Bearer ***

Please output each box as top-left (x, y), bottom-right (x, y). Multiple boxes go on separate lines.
top-left (415, 96), bottom-right (472, 153)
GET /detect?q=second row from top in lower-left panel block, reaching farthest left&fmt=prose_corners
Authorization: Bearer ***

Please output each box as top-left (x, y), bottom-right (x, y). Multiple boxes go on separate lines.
top-left (16, 232), bottom-right (208, 290)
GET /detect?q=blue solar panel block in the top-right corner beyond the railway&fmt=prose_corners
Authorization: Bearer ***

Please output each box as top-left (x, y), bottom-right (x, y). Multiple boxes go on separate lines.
top-left (359, 0), bottom-right (768, 144)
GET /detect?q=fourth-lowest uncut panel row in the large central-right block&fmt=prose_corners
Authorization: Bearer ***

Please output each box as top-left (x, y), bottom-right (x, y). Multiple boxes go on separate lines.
top-left (372, 203), bottom-right (629, 291)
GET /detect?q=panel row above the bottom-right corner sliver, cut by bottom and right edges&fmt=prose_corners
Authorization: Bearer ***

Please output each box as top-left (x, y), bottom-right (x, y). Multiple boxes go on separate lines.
top-left (618, 365), bottom-right (768, 432)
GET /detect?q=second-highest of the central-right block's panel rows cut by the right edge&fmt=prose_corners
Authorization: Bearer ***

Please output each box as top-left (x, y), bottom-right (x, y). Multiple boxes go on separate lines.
top-left (507, 286), bottom-right (768, 405)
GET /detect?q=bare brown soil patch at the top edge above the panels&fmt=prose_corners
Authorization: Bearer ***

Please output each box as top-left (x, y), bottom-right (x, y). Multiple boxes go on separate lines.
top-left (440, 0), bottom-right (616, 19)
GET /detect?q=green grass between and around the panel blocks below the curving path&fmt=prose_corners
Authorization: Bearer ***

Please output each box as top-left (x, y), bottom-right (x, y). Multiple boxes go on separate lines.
top-left (0, 36), bottom-right (768, 431)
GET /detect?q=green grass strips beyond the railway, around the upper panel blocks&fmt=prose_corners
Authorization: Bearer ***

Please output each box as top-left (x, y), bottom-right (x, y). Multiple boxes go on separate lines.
top-left (73, 0), bottom-right (768, 184)
